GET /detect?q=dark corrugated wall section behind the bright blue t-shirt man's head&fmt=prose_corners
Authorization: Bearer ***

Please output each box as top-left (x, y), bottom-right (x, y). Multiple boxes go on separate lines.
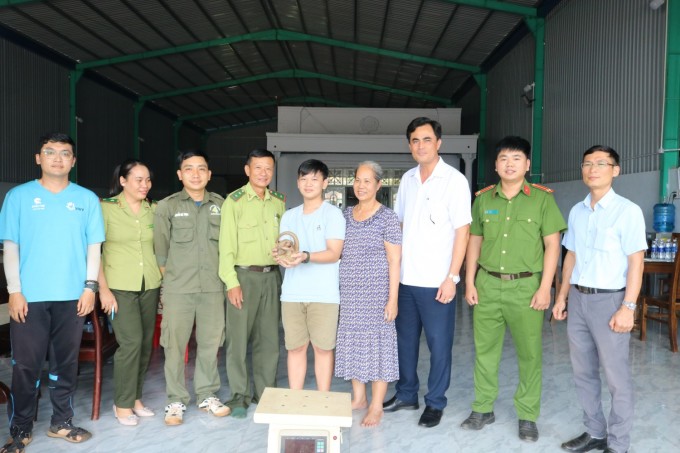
top-left (0, 38), bottom-right (69, 183)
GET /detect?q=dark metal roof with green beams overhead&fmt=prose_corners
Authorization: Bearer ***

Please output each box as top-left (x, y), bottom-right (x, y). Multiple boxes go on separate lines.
top-left (0, 0), bottom-right (559, 130)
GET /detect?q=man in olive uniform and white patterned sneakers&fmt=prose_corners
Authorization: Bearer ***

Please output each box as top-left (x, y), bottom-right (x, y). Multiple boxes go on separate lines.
top-left (154, 151), bottom-right (230, 425)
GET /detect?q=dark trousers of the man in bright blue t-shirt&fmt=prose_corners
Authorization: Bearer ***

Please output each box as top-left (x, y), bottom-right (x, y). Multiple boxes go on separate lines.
top-left (7, 300), bottom-right (85, 433)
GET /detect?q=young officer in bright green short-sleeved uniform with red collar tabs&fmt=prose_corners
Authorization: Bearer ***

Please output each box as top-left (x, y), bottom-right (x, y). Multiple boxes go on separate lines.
top-left (461, 137), bottom-right (566, 441)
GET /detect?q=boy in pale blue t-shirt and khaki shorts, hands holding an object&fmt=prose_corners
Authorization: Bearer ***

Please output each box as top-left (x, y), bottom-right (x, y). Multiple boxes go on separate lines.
top-left (274, 159), bottom-right (345, 391)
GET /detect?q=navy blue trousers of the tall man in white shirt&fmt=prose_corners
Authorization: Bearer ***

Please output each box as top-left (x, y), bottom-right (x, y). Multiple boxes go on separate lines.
top-left (396, 284), bottom-right (456, 410)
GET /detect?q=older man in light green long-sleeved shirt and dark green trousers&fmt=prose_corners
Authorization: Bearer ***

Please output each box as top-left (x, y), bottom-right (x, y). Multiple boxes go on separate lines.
top-left (220, 150), bottom-right (286, 418)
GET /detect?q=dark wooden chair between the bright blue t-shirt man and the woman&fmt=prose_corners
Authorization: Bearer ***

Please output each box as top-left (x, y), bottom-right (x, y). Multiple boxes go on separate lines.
top-left (78, 295), bottom-right (118, 420)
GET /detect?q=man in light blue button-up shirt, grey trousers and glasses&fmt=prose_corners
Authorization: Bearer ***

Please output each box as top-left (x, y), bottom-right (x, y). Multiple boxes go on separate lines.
top-left (553, 145), bottom-right (647, 453)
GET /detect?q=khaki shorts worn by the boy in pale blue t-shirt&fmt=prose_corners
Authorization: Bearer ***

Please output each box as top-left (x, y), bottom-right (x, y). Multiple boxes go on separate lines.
top-left (281, 302), bottom-right (340, 351)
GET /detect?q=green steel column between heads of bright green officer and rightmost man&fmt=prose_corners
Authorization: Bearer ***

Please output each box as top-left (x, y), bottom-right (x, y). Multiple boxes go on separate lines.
top-left (524, 17), bottom-right (545, 182)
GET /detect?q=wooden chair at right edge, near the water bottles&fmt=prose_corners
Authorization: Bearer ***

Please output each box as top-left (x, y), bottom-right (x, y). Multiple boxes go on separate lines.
top-left (640, 233), bottom-right (680, 352)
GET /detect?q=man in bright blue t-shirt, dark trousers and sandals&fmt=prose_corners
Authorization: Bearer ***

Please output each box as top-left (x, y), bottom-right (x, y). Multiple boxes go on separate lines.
top-left (0, 133), bottom-right (104, 452)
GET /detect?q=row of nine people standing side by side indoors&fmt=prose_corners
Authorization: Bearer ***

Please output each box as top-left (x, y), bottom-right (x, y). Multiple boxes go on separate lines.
top-left (0, 117), bottom-right (646, 453)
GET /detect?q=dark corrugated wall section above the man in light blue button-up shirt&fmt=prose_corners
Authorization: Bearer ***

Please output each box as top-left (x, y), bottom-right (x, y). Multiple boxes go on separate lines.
top-left (543, 0), bottom-right (666, 182)
